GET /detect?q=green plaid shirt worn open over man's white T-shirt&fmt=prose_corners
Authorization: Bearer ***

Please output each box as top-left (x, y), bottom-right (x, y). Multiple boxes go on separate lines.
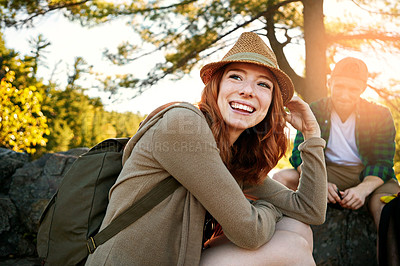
top-left (289, 98), bottom-right (396, 182)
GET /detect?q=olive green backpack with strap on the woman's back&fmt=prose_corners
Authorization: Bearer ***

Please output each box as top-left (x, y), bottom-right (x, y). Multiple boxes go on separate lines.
top-left (37, 103), bottom-right (180, 265)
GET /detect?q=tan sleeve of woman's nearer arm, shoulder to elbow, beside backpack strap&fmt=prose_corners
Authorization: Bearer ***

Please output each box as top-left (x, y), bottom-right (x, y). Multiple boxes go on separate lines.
top-left (152, 108), bottom-right (282, 249)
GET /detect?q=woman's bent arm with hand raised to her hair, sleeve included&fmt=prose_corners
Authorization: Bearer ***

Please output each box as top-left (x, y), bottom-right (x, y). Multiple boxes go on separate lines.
top-left (245, 96), bottom-right (327, 224)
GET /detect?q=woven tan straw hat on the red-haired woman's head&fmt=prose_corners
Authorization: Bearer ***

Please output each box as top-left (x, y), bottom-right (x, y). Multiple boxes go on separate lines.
top-left (200, 32), bottom-right (294, 104)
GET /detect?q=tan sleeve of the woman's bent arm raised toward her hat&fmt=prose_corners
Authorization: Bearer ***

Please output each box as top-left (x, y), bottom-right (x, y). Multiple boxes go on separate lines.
top-left (244, 138), bottom-right (327, 224)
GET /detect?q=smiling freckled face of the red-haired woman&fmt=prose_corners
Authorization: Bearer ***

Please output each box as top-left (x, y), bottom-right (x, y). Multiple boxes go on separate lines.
top-left (217, 63), bottom-right (275, 139)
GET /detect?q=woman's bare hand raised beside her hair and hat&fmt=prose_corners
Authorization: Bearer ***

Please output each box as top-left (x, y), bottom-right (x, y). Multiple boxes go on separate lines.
top-left (285, 96), bottom-right (321, 140)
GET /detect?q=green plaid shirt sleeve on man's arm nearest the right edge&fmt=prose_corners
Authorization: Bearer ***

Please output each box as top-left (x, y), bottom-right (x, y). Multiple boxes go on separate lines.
top-left (363, 108), bottom-right (396, 182)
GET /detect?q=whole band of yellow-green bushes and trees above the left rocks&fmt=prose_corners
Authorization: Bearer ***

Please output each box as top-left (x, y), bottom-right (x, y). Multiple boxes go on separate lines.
top-left (0, 31), bottom-right (144, 157)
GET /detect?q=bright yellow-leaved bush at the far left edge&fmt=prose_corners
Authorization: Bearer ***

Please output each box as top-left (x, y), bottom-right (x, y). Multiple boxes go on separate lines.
top-left (0, 32), bottom-right (49, 154)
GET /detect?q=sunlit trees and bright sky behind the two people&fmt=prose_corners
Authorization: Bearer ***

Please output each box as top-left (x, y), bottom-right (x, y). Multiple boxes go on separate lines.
top-left (0, 0), bottom-right (400, 177)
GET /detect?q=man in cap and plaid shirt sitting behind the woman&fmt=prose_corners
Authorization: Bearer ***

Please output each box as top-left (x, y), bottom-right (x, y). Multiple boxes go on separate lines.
top-left (273, 57), bottom-right (400, 262)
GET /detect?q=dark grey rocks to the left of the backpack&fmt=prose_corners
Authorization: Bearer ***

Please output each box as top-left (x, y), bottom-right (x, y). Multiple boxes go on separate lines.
top-left (0, 148), bottom-right (88, 258)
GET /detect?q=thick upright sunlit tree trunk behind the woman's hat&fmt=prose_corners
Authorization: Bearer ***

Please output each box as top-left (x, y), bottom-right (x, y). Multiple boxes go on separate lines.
top-left (299, 0), bottom-right (328, 103)
